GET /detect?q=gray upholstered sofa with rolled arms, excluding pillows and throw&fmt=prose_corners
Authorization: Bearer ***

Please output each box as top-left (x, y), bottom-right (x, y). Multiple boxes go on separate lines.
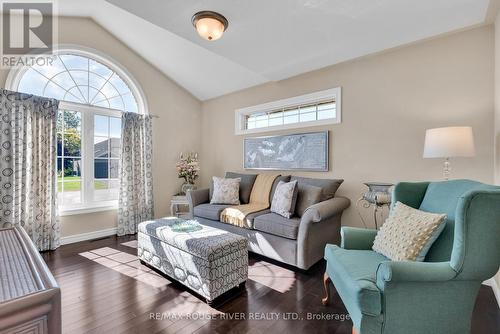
top-left (187, 173), bottom-right (350, 270)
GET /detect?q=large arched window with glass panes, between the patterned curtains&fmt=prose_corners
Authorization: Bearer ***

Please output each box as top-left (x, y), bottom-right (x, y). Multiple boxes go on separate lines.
top-left (6, 48), bottom-right (146, 214)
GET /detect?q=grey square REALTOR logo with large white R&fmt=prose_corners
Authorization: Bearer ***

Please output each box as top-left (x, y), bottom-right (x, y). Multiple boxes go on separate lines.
top-left (2, 2), bottom-right (54, 56)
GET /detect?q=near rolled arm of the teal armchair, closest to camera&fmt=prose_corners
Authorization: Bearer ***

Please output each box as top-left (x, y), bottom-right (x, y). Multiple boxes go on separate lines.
top-left (377, 261), bottom-right (457, 289)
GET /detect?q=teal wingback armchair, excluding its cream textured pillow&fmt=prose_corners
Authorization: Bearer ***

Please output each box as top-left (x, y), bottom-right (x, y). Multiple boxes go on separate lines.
top-left (323, 180), bottom-right (500, 334)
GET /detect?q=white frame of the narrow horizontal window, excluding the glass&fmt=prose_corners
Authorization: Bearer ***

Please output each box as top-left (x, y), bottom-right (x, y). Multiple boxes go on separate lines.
top-left (234, 87), bottom-right (342, 135)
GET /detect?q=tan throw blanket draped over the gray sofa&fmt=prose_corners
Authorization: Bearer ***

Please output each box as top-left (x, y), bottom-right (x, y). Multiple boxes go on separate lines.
top-left (220, 174), bottom-right (279, 228)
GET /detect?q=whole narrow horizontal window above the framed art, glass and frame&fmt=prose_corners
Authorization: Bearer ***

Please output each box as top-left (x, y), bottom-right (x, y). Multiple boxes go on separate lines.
top-left (235, 87), bottom-right (341, 134)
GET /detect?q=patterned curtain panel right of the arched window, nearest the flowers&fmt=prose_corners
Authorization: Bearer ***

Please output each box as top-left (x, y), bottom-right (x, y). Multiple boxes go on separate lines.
top-left (118, 113), bottom-right (153, 235)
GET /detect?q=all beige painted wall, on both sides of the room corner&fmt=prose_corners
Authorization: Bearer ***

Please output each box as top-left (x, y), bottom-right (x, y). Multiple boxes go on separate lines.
top-left (0, 18), bottom-right (494, 241)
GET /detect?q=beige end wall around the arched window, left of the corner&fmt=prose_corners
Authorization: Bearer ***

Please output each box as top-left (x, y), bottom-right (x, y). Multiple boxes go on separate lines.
top-left (0, 18), bottom-right (201, 236)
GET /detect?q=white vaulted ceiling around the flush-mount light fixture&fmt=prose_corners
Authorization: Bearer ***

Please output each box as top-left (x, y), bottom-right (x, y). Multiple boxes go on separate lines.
top-left (54, 0), bottom-right (490, 100)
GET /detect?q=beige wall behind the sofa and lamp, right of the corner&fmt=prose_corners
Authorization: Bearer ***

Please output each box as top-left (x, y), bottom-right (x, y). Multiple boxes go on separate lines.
top-left (201, 25), bottom-right (494, 226)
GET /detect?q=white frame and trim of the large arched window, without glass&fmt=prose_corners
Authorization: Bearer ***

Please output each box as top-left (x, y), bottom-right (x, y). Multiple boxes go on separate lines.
top-left (5, 44), bottom-right (148, 216)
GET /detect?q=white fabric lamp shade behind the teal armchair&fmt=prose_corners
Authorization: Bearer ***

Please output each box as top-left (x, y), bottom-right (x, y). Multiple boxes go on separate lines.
top-left (424, 126), bottom-right (475, 158)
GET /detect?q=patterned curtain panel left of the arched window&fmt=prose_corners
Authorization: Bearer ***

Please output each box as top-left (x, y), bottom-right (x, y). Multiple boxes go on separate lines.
top-left (0, 89), bottom-right (60, 250)
